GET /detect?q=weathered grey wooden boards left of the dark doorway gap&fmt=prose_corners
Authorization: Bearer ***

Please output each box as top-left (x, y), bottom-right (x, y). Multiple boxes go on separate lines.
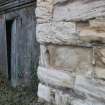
top-left (0, 16), bottom-right (8, 78)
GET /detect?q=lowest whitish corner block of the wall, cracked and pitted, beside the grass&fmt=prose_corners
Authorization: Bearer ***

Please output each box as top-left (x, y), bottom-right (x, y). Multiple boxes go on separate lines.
top-left (38, 83), bottom-right (71, 105)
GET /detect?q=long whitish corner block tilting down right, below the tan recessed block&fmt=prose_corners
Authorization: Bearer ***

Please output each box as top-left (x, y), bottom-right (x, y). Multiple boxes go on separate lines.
top-left (38, 67), bottom-right (74, 88)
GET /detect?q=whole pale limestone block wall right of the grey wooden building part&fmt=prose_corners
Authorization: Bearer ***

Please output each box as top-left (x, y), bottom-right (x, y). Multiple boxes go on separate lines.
top-left (35, 0), bottom-right (105, 105)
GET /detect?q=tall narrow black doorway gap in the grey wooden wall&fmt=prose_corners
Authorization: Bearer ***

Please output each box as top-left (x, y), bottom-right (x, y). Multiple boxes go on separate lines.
top-left (6, 20), bottom-right (13, 80)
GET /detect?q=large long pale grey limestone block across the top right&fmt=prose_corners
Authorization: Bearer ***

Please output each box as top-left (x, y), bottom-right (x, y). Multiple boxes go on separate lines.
top-left (53, 0), bottom-right (105, 21)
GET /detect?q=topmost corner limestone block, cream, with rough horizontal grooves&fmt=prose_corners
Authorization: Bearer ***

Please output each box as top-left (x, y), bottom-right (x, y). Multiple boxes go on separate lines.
top-left (35, 0), bottom-right (53, 23)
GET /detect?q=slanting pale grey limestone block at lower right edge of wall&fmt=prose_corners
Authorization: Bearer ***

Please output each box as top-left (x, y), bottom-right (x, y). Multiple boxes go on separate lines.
top-left (74, 75), bottom-right (105, 102)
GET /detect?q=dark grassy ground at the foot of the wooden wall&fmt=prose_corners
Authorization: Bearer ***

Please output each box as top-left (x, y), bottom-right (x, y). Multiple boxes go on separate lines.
top-left (0, 74), bottom-right (39, 105)
